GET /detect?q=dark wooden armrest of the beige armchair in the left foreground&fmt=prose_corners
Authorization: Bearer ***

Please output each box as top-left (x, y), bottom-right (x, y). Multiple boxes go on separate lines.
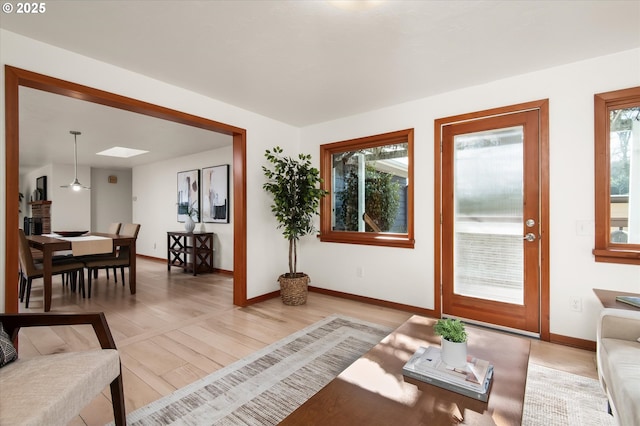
top-left (0, 312), bottom-right (117, 349)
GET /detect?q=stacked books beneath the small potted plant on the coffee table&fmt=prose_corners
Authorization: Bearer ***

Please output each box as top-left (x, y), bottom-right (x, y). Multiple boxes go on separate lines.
top-left (402, 346), bottom-right (493, 402)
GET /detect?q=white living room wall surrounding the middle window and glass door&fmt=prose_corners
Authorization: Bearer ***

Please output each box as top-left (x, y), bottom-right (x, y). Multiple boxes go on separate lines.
top-left (300, 49), bottom-right (640, 340)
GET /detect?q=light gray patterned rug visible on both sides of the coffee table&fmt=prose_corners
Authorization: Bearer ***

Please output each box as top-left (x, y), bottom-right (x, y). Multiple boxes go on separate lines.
top-left (119, 316), bottom-right (615, 426)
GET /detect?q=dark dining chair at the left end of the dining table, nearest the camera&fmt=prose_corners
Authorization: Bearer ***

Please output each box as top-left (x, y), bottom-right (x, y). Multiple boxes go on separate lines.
top-left (18, 229), bottom-right (84, 308)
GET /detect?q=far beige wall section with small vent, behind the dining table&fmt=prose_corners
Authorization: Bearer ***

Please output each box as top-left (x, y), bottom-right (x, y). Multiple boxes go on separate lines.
top-left (91, 168), bottom-right (133, 232)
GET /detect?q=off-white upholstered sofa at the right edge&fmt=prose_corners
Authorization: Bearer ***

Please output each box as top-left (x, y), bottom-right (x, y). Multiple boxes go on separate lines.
top-left (596, 309), bottom-right (640, 426)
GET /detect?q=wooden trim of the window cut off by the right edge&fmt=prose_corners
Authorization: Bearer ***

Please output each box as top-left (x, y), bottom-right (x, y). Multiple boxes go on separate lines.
top-left (593, 87), bottom-right (640, 265)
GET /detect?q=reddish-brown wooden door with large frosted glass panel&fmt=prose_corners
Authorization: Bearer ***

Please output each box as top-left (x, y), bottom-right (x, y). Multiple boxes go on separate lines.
top-left (442, 110), bottom-right (540, 333)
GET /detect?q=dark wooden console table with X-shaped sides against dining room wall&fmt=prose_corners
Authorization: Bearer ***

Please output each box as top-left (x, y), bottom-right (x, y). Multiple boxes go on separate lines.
top-left (167, 232), bottom-right (213, 275)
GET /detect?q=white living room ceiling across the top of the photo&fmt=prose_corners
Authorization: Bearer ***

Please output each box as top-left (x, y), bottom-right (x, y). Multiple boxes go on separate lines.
top-left (0, 0), bottom-right (640, 171)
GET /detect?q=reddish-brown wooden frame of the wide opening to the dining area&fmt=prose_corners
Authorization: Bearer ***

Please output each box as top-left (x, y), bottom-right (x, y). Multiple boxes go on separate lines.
top-left (4, 65), bottom-right (248, 313)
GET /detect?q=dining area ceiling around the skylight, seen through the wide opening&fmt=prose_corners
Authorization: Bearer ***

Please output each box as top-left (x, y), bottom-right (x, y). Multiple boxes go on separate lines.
top-left (19, 87), bottom-right (233, 173)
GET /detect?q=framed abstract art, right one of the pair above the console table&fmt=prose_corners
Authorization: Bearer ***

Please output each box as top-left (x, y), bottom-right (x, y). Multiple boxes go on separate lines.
top-left (202, 164), bottom-right (229, 223)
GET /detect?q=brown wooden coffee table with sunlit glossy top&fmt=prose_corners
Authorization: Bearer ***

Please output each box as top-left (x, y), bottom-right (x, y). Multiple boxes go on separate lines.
top-left (281, 315), bottom-right (530, 425)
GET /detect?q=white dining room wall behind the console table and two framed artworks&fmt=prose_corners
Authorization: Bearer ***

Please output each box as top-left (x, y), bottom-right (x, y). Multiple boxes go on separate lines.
top-left (131, 145), bottom-right (234, 271)
